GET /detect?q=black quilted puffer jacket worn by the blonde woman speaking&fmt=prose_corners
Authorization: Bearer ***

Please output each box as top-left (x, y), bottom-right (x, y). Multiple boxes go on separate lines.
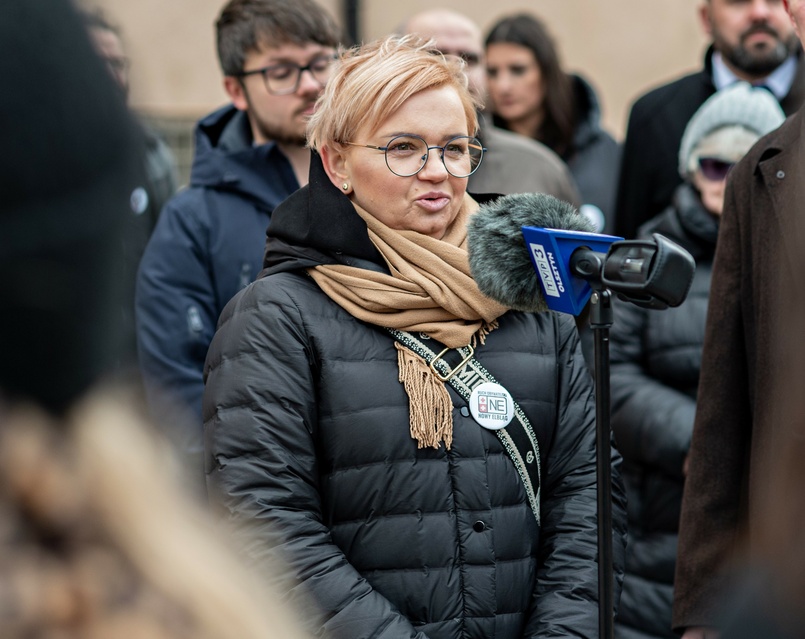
top-left (204, 152), bottom-right (625, 639)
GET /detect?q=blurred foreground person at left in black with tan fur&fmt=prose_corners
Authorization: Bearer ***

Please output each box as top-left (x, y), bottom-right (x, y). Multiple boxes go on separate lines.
top-left (0, 0), bottom-right (312, 639)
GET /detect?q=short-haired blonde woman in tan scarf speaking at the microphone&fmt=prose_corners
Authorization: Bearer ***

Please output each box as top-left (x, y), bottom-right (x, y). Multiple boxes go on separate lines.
top-left (204, 36), bottom-right (625, 639)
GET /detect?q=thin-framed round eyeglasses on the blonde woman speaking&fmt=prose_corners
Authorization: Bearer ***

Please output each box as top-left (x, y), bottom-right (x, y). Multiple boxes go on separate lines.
top-left (344, 135), bottom-right (486, 177)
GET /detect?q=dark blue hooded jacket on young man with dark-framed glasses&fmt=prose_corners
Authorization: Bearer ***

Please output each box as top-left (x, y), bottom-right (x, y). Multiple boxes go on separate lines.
top-left (136, 106), bottom-right (299, 469)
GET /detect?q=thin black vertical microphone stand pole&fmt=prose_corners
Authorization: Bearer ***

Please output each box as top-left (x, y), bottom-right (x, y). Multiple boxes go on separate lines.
top-left (590, 281), bottom-right (615, 639)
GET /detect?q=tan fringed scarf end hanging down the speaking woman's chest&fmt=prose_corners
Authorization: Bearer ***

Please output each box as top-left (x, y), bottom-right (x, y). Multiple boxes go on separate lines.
top-left (394, 342), bottom-right (453, 450)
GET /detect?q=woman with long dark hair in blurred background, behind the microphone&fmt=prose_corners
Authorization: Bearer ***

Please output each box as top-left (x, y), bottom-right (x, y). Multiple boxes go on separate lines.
top-left (484, 13), bottom-right (621, 233)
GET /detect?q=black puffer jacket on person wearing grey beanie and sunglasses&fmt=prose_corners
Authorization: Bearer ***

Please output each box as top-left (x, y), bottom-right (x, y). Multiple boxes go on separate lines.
top-left (610, 184), bottom-right (718, 639)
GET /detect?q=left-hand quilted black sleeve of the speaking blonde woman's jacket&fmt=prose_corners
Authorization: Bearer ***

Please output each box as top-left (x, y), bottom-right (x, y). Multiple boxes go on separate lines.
top-left (204, 278), bottom-right (425, 639)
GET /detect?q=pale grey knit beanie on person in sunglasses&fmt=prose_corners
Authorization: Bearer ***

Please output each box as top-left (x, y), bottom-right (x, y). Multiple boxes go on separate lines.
top-left (679, 82), bottom-right (785, 178)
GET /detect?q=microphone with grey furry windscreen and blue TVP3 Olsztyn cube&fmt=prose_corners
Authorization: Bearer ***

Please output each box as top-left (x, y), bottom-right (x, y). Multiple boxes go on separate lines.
top-left (467, 193), bottom-right (622, 315)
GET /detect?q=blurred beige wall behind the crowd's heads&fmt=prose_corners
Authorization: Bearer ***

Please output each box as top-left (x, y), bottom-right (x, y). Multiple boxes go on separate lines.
top-left (81, 0), bottom-right (706, 138)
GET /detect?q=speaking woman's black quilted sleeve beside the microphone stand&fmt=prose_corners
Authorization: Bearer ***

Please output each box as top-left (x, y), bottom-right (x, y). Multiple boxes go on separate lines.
top-left (525, 318), bottom-right (626, 638)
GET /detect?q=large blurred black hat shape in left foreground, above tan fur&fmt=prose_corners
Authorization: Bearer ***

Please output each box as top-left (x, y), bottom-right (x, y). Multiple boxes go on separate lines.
top-left (0, 0), bottom-right (142, 412)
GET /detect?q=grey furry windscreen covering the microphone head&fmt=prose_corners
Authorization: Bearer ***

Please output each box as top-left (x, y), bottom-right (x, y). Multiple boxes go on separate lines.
top-left (467, 193), bottom-right (595, 313)
